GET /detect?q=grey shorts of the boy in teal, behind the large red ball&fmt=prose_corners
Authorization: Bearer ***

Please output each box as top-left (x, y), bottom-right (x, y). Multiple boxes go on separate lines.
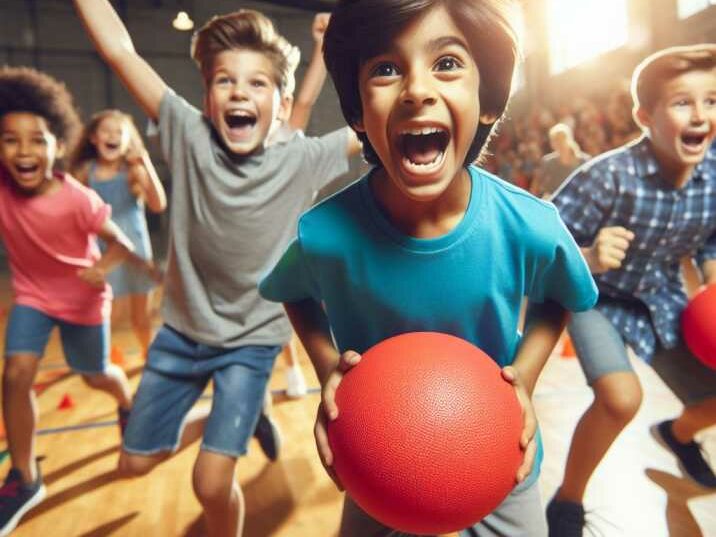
top-left (338, 481), bottom-right (547, 537)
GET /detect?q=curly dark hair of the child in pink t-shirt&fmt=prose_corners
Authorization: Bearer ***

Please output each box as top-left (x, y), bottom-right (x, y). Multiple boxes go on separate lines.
top-left (0, 66), bottom-right (82, 150)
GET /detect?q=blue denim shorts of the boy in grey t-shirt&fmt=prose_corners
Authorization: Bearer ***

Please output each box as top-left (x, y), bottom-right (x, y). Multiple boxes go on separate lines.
top-left (124, 325), bottom-right (281, 457)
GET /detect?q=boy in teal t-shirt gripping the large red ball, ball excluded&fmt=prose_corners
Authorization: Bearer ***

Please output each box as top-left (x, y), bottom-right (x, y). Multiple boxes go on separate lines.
top-left (259, 0), bottom-right (597, 536)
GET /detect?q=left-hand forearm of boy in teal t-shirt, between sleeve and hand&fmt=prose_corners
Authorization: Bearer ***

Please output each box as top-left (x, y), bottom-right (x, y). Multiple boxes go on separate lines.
top-left (283, 299), bottom-right (339, 386)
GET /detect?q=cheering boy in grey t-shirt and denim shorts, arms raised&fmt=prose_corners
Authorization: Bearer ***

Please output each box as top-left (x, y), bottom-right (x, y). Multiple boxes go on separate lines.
top-left (75, 0), bottom-right (358, 536)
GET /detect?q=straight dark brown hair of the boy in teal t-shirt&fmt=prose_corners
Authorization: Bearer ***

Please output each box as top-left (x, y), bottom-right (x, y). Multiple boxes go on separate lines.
top-left (323, 0), bottom-right (519, 165)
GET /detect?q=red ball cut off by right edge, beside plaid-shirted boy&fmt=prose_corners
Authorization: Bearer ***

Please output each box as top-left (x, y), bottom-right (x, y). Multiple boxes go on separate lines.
top-left (684, 285), bottom-right (716, 368)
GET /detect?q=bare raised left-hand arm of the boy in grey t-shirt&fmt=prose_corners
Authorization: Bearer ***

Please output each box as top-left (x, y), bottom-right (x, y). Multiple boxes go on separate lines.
top-left (74, 0), bottom-right (167, 120)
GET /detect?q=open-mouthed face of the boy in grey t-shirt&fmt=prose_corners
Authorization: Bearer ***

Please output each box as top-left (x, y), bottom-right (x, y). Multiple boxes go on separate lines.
top-left (204, 49), bottom-right (287, 156)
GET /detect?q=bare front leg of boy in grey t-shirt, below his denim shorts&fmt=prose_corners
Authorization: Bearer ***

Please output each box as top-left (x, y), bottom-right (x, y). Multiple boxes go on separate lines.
top-left (193, 451), bottom-right (244, 537)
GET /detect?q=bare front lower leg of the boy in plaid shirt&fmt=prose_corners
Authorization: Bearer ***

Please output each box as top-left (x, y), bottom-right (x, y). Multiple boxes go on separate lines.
top-left (557, 372), bottom-right (642, 503)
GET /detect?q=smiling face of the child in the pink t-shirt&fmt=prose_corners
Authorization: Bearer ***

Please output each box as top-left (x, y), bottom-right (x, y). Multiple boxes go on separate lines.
top-left (0, 112), bottom-right (62, 195)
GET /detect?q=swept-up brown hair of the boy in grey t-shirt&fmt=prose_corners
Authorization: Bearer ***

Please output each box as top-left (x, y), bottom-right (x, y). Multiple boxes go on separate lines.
top-left (191, 9), bottom-right (300, 94)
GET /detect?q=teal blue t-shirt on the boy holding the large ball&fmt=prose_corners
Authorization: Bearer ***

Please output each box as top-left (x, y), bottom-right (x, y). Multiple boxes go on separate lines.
top-left (259, 163), bottom-right (597, 477)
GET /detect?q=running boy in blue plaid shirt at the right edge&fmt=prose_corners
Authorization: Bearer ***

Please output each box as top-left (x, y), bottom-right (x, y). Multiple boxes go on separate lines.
top-left (547, 44), bottom-right (716, 537)
